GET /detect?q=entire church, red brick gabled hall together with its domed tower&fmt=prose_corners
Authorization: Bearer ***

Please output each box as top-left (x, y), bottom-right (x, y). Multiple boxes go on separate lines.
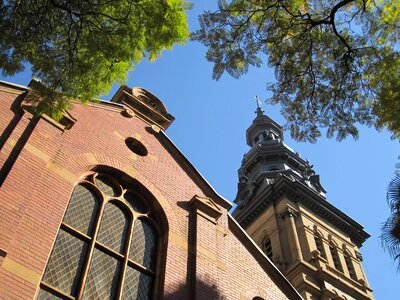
top-left (0, 81), bottom-right (373, 300)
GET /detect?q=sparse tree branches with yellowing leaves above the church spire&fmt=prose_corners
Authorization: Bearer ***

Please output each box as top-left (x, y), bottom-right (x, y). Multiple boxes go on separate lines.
top-left (193, 0), bottom-right (400, 142)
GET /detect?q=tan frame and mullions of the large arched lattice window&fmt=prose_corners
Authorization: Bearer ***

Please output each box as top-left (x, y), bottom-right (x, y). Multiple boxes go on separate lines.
top-left (38, 171), bottom-right (165, 300)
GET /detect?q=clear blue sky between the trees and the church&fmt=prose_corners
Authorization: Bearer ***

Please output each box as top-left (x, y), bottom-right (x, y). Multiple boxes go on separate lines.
top-left (0, 0), bottom-right (400, 299)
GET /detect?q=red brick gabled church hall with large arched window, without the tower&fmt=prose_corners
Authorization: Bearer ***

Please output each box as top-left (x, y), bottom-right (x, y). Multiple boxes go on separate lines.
top-left (0, 82), bottom-right (301, 300)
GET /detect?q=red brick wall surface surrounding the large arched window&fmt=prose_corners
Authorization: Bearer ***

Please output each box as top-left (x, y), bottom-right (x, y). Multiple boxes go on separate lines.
top-left (0, 87), bottom-right (294, 299)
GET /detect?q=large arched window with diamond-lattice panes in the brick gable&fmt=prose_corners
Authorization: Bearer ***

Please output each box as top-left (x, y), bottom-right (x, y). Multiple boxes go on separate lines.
top-left (37, 172), bottom-right (160, 299)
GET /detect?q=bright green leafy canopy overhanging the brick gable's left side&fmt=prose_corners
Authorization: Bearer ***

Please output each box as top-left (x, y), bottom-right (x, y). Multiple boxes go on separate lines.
top-left (0, 0), bottom-right (189, 119)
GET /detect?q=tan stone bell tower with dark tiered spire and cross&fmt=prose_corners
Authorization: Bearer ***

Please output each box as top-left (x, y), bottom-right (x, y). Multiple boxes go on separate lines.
top-left (233, 99), bottom-right (373, 300)
